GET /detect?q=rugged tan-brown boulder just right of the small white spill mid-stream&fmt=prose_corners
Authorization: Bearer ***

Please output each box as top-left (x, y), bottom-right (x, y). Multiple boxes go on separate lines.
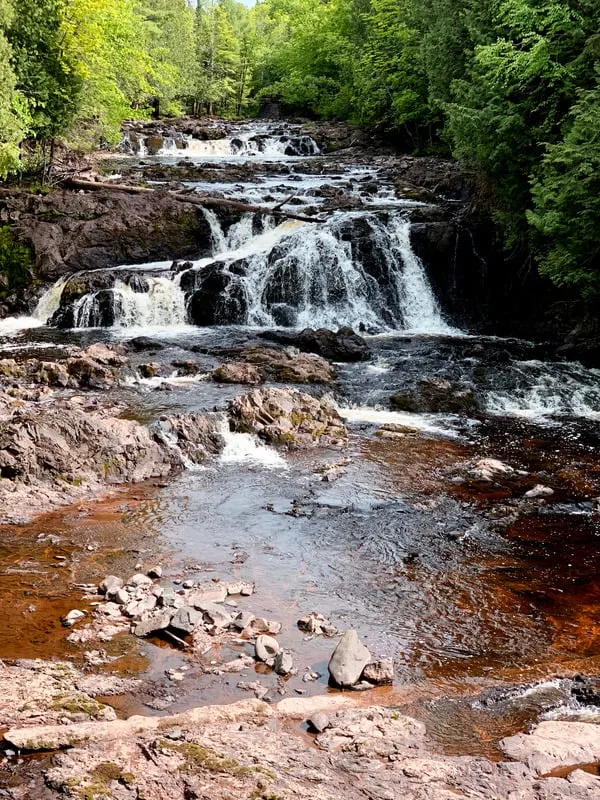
top-left (229, 389), bottom-right (348, 449)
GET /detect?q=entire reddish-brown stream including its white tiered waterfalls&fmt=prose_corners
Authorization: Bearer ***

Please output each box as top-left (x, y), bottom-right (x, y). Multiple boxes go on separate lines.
top-left (0, 123), bottom-right (600, 758)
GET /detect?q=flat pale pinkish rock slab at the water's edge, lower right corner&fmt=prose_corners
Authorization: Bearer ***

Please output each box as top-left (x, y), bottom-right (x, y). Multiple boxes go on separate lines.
top-left (500, 721), bottom-right (600, 775)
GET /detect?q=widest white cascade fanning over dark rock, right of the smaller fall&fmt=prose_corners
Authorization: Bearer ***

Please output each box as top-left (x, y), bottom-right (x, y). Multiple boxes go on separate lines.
top-left (184, 212), bottom-right (456, 334)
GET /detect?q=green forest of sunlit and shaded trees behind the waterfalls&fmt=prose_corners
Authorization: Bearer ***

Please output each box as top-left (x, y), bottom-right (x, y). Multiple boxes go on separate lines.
top-left (0, 0), bottom-right (600, 295)
